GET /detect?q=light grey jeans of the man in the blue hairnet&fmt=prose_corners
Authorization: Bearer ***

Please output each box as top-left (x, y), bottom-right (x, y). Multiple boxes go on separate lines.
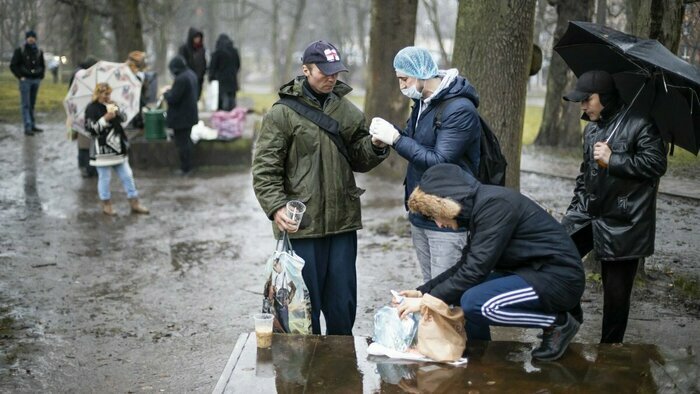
top-left (411, 224), bottom-right (467, 283)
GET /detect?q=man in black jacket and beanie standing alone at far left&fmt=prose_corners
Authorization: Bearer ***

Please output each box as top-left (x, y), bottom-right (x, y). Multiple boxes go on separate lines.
top-left (10, 30), bottom-right (46, 135)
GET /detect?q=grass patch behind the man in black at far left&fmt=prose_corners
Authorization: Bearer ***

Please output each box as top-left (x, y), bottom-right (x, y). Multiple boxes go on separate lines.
top-left (0, 68), bottom-right (68, 121)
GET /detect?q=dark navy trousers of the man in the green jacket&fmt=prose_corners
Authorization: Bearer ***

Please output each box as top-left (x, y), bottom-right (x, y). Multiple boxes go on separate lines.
top-left (291, 231), bottom-right (357, 335)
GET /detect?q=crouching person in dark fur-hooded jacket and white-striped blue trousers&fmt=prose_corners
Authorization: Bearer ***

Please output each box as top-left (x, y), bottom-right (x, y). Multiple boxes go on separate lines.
top-left (398, 164), bottom-right (586, 361)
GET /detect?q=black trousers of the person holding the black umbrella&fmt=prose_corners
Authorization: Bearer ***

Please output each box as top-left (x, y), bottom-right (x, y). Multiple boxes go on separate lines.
top-left (600, 259), bottom-right (639, 343)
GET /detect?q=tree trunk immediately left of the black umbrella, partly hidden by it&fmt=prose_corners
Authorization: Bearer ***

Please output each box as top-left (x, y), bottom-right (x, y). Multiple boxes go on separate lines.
top-left (535, 0), bottom-right (593, 148)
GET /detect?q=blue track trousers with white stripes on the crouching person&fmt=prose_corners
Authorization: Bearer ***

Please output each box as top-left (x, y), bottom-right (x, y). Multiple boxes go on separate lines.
top-left (460, 272), bottom-right (557, 341)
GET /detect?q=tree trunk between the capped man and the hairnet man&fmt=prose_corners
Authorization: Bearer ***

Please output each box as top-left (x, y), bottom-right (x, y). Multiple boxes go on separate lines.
top-left (365, 0), bottom-right (418, 174)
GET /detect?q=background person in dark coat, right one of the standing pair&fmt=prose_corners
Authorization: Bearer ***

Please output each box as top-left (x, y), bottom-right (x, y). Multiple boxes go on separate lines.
top-left (209, 34), bottom-right (241, 111)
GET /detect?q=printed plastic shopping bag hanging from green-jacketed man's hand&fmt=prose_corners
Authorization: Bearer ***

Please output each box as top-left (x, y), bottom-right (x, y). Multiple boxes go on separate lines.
top-left (262, 232), bottom-right (311, 335)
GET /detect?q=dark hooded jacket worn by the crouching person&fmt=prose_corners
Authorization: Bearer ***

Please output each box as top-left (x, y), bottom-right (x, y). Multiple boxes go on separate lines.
top-left (416, 164), bottom-right (585, 312)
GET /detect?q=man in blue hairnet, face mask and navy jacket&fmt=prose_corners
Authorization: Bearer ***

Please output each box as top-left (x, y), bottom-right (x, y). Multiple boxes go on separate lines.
top-left (370, 47), bottom-right (481, 281)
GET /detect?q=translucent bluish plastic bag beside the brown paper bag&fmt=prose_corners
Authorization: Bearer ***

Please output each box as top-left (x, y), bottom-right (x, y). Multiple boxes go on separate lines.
top-left (372, 306), bottom-right (418, 352)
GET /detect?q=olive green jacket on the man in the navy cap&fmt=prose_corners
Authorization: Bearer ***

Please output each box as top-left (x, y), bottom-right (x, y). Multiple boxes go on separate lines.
top-left (253, 76), bottom-right (389, 238)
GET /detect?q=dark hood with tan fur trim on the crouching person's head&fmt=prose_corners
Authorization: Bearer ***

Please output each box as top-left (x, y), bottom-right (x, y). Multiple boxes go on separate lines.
top-left (408, 163), bottom-right (481, 226)
